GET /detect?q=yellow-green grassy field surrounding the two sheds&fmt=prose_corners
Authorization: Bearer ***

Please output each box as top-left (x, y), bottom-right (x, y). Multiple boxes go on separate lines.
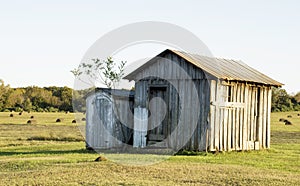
top-left (0, 112), bottom-right (300, 185)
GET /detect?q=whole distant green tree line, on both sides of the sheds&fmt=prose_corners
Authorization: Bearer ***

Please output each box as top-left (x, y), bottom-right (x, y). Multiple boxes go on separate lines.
top-left (0, 79), bottom-right (300, 112)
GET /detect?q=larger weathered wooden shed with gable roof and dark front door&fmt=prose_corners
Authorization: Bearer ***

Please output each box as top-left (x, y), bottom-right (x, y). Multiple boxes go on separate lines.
top-left (125, 49), bottom-right (282, 151)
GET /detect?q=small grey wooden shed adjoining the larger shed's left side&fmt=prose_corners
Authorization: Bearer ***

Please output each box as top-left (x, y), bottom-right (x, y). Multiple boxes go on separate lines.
top-left (85, 88), bottom-right (134, 149)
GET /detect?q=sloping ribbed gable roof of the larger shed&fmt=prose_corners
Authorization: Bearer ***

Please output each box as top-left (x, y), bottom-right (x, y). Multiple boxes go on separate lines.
top-left (125, 49), bottom-right (283, 87)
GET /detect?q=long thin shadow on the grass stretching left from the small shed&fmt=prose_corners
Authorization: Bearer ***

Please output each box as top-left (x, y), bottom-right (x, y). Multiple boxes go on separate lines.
top-left (0, 149), bottom-right (97, 156)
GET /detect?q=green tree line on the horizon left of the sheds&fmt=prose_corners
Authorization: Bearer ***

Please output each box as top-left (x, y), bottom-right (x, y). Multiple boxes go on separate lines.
top-left (0, 80), bottom-right (85, 112)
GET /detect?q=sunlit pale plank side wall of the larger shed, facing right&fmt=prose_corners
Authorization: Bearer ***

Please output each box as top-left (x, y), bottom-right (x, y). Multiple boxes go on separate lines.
top-left (208, 80), bottom-right (272, 151)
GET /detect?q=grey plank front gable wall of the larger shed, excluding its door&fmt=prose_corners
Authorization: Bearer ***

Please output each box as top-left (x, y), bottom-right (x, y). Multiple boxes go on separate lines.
top-left (134, 54), bottom-right (210, 150)
